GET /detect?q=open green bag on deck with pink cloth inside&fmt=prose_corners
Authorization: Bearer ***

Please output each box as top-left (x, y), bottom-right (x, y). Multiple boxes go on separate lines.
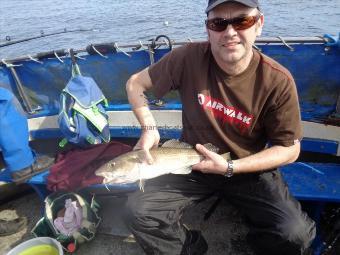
top-left (31, 192), bottom-right (101, 252)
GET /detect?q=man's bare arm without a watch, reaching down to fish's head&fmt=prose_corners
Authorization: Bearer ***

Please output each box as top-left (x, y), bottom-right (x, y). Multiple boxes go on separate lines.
top-left (126, 68), bottom-right (160, 164)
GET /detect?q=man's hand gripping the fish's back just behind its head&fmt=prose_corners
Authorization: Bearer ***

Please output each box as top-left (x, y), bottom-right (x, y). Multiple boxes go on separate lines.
top-left (133, 129), bottom-right (160, 165)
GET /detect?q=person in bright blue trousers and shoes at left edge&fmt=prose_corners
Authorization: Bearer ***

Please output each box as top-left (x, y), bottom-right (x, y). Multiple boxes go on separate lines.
top-left (0, 87), bottom-right (54, 236)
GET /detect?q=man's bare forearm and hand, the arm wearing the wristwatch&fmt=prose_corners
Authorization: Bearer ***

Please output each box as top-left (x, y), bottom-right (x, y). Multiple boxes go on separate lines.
top-left (193, 143), bottom-right (300, 174)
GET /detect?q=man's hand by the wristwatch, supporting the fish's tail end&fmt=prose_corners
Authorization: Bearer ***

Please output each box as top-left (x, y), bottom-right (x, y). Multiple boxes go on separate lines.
top-left (192, 144), bottom-right (227, 174)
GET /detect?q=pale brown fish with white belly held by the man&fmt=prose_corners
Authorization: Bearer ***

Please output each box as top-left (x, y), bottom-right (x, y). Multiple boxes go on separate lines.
top-left (95, 139), bottom-right (230, 190)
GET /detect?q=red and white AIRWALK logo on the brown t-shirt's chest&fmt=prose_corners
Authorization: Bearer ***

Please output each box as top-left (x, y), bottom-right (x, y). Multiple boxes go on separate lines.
top-left (198, 94), bottom-right (253, 131)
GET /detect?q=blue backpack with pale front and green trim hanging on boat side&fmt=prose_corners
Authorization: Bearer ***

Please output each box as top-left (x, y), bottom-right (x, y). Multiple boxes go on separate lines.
top-left (58, 53), bottom-right (110, 147)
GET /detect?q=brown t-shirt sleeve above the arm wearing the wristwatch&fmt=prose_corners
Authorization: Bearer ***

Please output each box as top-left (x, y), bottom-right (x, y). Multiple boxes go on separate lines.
top-left (265, 79), bottom-right (302, 146)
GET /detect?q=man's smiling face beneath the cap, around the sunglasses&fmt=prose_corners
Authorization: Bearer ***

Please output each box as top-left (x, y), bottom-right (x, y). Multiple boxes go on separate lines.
top-left (207, 2), bottom-right (263, 68)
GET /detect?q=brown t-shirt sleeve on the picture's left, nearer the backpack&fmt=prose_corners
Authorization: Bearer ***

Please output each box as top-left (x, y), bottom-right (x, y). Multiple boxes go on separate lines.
top-left (149, 46), bottom-right (188, 99)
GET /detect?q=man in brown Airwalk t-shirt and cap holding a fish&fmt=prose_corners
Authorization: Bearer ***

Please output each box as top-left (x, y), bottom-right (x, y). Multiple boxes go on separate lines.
top-left (126, 0), bottom-right (315, 255)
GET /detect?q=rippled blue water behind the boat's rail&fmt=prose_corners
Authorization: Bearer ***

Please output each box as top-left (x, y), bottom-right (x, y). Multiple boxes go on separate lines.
top-left (0, 0), bottom-right (340, 58)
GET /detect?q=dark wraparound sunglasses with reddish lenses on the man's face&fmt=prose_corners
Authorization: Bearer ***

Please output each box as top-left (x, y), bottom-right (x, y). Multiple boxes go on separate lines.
top-left (205, 14), bottom-right (261, 32)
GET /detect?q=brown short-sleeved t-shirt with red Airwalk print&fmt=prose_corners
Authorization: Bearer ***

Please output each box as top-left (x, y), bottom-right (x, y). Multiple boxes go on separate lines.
top-left (149, 42), bottom-right (302, 158)
